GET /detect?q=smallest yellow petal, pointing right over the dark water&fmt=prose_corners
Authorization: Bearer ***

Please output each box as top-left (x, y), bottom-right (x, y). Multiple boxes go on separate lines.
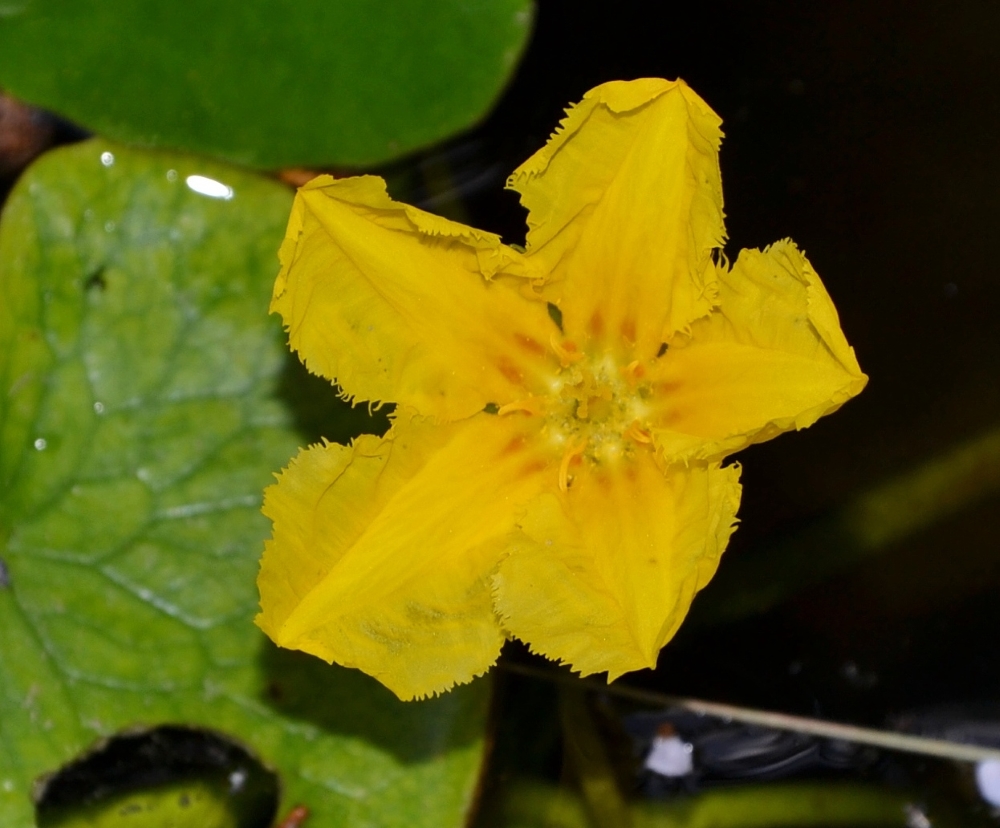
top-left (653, 241), bottom-right (868, 463)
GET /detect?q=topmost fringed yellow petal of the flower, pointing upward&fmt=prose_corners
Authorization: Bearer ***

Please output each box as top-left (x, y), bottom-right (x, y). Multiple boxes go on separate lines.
top-left (508, 78), bottom-right (725, 357)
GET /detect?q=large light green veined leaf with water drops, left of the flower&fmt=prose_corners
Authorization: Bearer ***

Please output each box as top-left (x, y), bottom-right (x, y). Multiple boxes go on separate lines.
top-left (0, 142), bottom-right (489, 828)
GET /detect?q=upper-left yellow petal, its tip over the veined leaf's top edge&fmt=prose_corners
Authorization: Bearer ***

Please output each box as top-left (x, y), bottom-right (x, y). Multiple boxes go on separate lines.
top-left (271, 176), bottom-right (554, 420)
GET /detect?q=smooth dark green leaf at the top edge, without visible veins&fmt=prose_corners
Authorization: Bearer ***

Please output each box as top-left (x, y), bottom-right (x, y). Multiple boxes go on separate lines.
top-left (0, 0), bottom-right (533, 168)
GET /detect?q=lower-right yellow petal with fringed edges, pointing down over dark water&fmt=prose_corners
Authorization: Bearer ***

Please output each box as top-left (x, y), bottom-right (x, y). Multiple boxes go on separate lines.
top-left (494, 453), bottom-right (740, 681)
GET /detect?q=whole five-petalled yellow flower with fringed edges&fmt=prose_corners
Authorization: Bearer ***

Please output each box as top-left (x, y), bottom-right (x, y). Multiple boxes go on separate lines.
top-left (257, 79), bottom-right (866, 699)
